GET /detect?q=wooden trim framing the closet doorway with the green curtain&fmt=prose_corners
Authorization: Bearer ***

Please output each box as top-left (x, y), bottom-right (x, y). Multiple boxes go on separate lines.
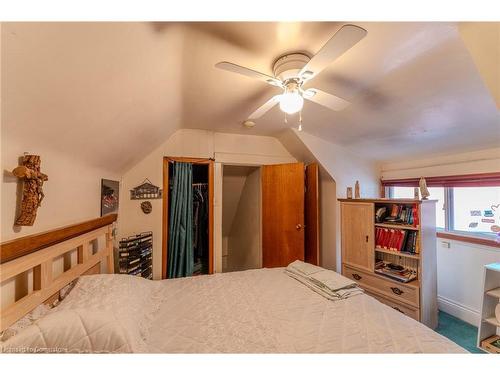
top-left (161, 156), bottom-right (214, 279)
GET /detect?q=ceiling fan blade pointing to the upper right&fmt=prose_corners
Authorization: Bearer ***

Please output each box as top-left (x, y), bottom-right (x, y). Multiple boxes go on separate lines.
top-left (299, 25), bottom-right (367, 80)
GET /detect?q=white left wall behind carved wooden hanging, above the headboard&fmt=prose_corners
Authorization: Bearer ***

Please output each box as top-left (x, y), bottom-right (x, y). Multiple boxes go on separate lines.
top-left (1, 135), bottom-right (119, 241)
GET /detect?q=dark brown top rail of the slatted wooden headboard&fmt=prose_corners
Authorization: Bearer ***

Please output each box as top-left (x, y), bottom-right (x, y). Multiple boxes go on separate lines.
top-left (0, 214), bottom-right (118, 264)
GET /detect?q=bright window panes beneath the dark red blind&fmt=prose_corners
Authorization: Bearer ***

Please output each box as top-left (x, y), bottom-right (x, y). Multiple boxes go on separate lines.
top-left (388, 186), bottom-right (500, 236)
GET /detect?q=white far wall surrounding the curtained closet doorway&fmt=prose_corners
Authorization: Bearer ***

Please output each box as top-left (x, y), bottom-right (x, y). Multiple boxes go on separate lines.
top-left (119, 129), bottom-right (296, 279)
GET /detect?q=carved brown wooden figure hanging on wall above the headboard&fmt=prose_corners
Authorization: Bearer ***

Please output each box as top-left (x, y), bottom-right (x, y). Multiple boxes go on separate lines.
top-left (12, 155), bottom-right (49, 226)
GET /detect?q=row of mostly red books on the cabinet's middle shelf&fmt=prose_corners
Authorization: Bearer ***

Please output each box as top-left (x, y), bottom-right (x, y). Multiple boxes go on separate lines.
top-left (375, 227), bottom-right (419, 254)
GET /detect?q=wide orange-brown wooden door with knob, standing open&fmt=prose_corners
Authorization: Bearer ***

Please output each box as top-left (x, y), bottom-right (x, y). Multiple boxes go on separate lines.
top-left (262, 163), bottom-right (304, 267)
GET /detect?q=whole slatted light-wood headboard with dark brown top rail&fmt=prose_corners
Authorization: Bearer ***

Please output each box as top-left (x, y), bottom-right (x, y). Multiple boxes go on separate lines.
top-left (0, 214), bottom-right (117, 331)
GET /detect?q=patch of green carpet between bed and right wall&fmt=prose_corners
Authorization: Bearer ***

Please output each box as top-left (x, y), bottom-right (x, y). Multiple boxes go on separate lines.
top-left (436, 311), bottom-right (484, 354)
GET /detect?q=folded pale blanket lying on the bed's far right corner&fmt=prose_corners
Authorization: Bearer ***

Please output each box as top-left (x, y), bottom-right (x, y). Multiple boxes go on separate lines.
top-left (285, 260), bottom-right (363, 300)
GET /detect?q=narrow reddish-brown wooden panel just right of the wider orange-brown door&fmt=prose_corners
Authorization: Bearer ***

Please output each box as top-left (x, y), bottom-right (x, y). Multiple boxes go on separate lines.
top-left (304, 163), bottom-right (319, 265)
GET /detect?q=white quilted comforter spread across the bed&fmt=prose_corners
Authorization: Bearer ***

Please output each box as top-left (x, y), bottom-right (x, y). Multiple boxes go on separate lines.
top-left (1, 268), bottom-right (465, 353)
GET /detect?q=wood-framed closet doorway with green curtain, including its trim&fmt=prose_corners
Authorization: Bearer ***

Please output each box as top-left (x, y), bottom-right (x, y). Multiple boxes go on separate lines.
top-left (162, 157), bottom-right (214, 279)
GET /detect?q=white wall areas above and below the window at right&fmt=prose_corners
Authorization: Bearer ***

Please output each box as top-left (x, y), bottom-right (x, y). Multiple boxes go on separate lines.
top-left (381, 148), bottom-right (500, 326)
